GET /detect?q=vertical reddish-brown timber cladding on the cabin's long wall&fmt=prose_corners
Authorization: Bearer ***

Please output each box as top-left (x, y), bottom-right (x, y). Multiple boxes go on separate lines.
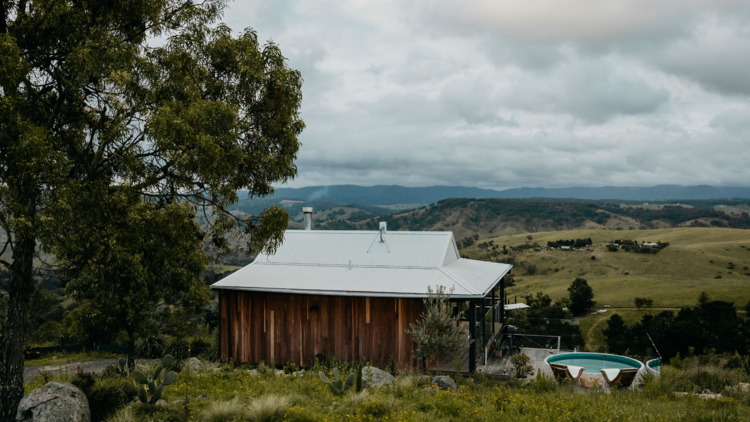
top-left (220, 290), bottom-right (422, 367)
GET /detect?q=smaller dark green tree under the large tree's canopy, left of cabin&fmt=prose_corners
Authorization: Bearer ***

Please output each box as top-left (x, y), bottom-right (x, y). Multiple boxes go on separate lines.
top-left (56, 198), bottom-right (210, 366)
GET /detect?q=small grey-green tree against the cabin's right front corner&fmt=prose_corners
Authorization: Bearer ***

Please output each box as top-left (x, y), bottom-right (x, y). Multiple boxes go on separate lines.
top-left (406, 286), bottom-right (473, 370)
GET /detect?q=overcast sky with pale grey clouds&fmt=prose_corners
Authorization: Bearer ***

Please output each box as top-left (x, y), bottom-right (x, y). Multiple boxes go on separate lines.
top-left (224, 0), bottom-right (750, 188)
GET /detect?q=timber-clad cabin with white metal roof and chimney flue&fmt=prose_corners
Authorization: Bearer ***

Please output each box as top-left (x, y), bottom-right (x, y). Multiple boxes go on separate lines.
top-left (211, 213), bottom-right (511, 370)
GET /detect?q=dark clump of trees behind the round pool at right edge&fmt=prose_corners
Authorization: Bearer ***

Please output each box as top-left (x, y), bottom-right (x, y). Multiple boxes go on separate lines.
top-left (603, 293), bottom-right (750, 360)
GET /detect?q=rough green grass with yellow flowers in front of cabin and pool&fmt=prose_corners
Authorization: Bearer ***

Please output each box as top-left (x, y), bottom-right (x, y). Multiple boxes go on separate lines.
top-left (32, 358), bottom-right (750, 422)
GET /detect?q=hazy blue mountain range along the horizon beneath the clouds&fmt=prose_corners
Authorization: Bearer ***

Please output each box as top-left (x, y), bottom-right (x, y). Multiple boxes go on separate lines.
top-left (266, 185), bottom-right (750, 205)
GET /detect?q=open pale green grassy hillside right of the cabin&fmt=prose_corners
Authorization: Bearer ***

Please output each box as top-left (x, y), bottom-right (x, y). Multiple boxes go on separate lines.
top-left (461, 228), bottom-right (750, 348)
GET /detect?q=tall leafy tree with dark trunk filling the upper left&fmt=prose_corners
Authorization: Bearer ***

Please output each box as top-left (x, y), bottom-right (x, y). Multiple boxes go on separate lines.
top-left (0, 0), bottom-right (304, 422)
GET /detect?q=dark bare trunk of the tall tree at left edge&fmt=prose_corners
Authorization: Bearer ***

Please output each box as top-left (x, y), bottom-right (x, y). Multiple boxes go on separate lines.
top-left (0, 236), bottom-right (36, 422)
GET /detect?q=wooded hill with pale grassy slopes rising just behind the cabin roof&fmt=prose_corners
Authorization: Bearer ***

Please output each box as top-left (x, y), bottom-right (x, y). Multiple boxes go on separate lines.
top-left (302, 198), bottom-right (750, 239)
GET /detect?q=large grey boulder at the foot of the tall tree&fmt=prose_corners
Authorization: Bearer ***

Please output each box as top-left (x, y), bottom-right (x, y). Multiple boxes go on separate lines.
top-left (16, 382), bottom-right (91, 422)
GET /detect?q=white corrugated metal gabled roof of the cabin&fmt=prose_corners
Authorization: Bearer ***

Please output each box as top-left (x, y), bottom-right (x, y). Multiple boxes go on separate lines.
top-left (211, 230), bottom-right (511, 298)
